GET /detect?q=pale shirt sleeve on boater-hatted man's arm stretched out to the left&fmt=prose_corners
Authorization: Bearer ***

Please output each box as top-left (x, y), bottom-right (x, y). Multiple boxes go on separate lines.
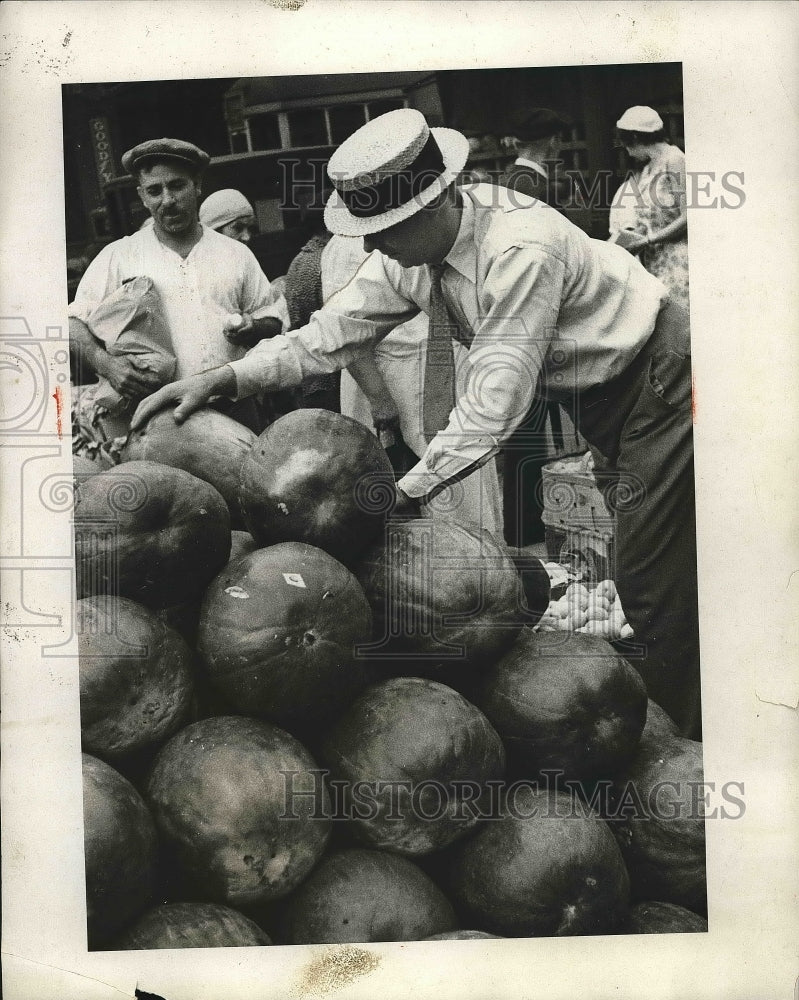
top-left (229, 253), bottom-right (419, 399)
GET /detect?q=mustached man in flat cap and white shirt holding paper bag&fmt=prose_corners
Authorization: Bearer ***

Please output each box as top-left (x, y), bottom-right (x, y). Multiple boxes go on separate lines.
top-left (69, 139), bottom-right (288, 438)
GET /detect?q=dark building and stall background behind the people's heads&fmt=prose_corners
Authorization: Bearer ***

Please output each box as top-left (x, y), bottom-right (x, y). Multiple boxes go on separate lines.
top-left (62, 63), bottom-right (685, 293)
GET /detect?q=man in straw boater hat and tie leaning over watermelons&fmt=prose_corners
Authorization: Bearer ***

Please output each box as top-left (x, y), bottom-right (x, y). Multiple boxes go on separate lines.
top-left (134, 109), bottom-right (700, 736)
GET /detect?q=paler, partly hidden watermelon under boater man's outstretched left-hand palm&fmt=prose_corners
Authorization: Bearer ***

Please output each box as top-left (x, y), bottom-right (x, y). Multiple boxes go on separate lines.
top-left (122, 409), bottom-right (256, 525)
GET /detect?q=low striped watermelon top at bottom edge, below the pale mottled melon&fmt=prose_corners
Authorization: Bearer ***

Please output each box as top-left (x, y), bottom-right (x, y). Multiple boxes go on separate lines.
top-left (114, 902), bottom-right (272, 951)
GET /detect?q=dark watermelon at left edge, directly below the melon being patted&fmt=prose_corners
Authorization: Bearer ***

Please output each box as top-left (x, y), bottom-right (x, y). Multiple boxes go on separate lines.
top-left (75, 462), bottom-right (230, 608)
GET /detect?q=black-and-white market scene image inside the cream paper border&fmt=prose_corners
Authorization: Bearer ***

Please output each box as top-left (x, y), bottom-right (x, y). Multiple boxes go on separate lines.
top-left (63, 64), bottom-right (707, 949)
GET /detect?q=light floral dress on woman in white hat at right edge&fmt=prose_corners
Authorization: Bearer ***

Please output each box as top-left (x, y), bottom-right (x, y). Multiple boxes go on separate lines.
top-left (610, 144), bottom-right (688, 309)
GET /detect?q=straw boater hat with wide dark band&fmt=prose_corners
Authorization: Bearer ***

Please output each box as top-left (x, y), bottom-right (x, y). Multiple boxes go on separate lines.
top-left (325, 108), bottom-right (469, 236)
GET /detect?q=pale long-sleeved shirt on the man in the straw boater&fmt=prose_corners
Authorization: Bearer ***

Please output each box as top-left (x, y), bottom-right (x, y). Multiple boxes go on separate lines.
top-left (230, 184), bottom-right (666, 497)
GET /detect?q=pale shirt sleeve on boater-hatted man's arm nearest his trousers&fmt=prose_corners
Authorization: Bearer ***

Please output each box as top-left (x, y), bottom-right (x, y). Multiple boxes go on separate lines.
top-left (398, 247), bottom-right (565, 498)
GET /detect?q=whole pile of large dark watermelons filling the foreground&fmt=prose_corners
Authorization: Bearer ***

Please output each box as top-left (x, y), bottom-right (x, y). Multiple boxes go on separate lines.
top-left (75, 410), bottom-right (707, 949)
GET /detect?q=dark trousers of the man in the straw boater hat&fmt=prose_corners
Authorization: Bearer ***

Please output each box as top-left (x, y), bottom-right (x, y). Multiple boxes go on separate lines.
top-left (564, 302), bottom-right (701, 739)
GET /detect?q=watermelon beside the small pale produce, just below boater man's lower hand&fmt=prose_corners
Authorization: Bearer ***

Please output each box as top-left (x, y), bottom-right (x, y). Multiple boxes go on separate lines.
top-left (356, 518), bottom-right (524, 676)
